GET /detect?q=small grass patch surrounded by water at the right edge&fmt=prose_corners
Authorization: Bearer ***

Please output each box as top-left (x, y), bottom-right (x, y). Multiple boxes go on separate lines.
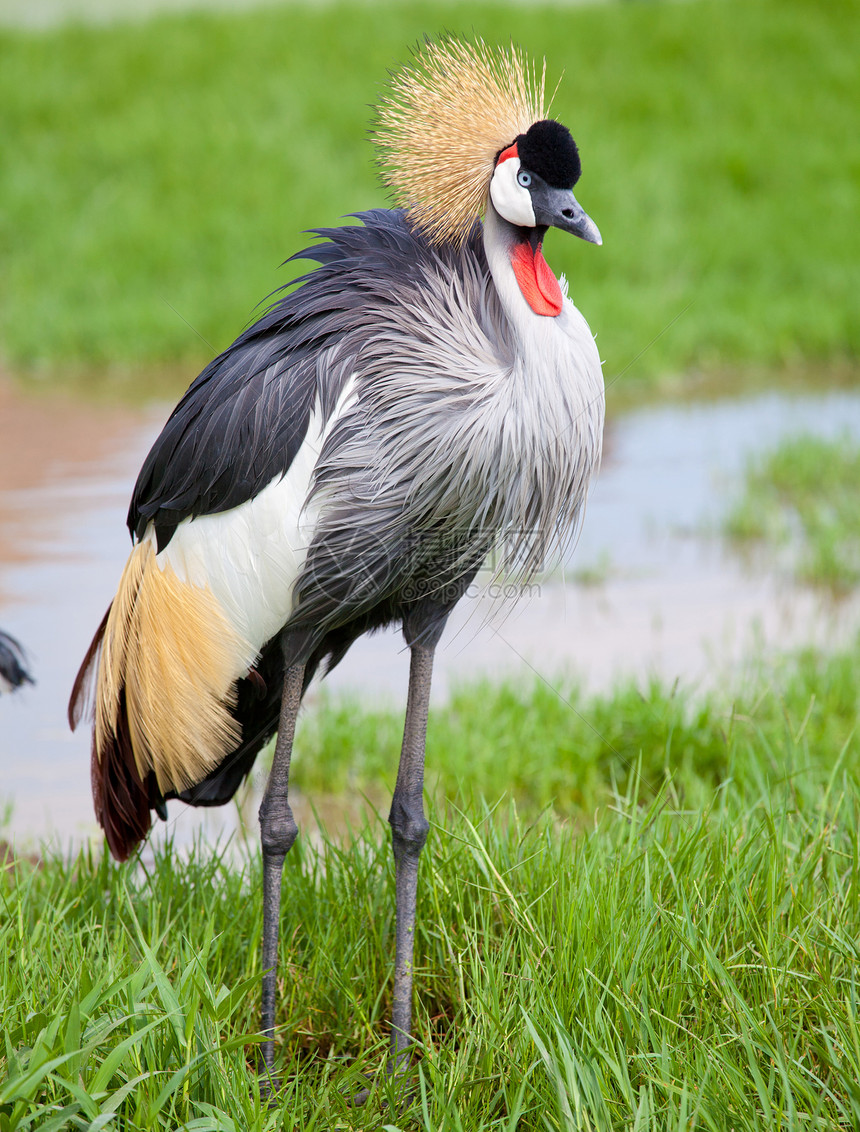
top-left (725, 436), bottom-right (860, 593)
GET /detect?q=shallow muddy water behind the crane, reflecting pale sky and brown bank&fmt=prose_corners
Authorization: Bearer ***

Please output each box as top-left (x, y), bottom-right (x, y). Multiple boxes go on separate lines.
top-left (0, 384), bottom-right (860, 846)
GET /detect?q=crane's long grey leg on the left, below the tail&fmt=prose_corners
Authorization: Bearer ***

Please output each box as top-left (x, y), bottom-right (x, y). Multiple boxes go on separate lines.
top-left (259, 664), bottom-right (304, 1096)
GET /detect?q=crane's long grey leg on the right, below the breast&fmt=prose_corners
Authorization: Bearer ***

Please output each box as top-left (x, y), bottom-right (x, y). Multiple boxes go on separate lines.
top-left (388, 644), bottom-right (435, 1075)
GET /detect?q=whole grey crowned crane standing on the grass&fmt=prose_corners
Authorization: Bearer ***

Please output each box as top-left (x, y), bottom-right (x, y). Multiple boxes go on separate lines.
top-left (69, 35), bottom-right (604, 1089)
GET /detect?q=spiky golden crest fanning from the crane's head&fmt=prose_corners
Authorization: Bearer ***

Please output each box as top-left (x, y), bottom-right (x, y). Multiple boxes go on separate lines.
top-left (372, 37), bottom-right (545, 245)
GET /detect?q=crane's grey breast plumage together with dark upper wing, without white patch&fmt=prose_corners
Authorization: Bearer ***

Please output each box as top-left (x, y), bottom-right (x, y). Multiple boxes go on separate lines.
top-left (129, 209), bottom-right (603, 661)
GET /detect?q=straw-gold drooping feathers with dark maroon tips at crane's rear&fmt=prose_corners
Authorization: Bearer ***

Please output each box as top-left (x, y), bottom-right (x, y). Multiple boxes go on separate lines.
top-left (69, 540), bottom-right (255, 860)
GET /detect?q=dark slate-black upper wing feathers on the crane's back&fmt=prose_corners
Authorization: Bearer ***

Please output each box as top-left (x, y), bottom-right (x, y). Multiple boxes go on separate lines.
top-left (128, 209), bottom-right (432, 550)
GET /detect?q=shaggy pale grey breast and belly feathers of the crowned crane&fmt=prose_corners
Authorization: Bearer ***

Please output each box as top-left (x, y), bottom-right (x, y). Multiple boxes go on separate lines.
top-left (285, 212), bottom-right (603, 634)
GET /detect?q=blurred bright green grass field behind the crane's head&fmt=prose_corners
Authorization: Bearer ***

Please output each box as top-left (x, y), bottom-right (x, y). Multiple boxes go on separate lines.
top-left (0, 0), bottom-right (860, 391)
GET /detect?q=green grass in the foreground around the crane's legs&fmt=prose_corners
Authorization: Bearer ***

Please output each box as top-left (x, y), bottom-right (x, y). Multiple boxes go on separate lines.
top-left (0, 651), bottom-right (860, 1132)
